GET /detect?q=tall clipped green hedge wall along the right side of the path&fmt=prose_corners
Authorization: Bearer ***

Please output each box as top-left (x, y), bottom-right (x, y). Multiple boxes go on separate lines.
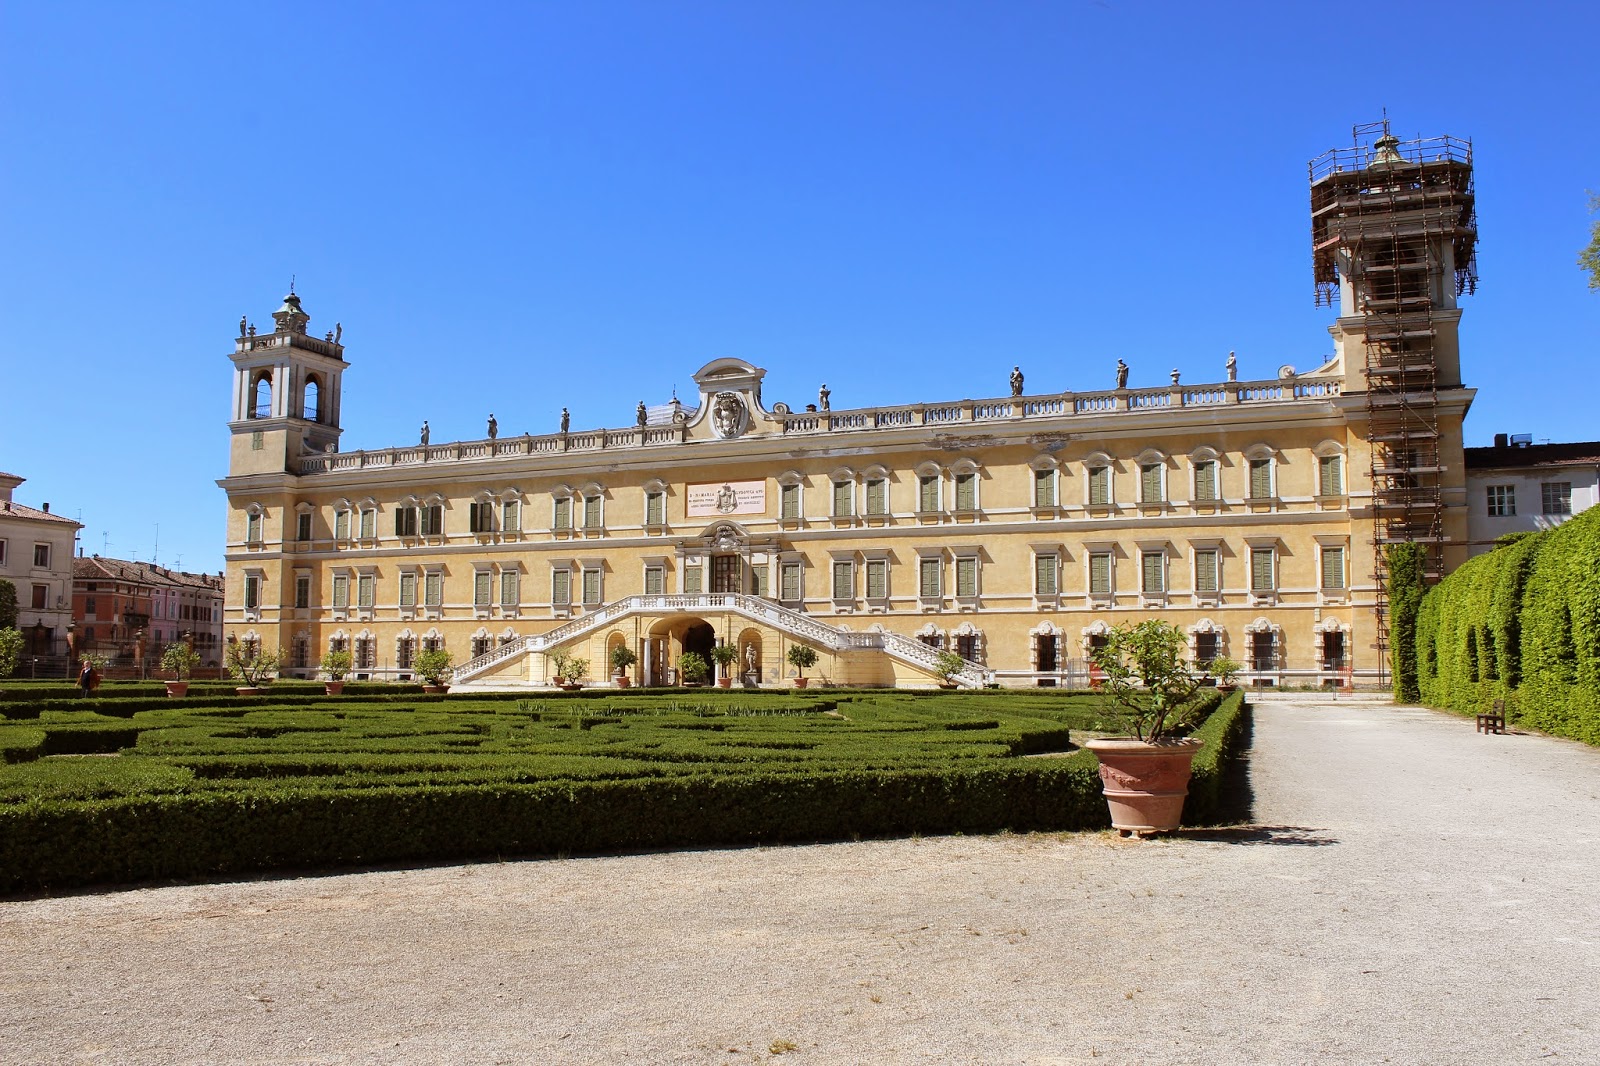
top-left (1414, 509), bottom-right (1600, 744)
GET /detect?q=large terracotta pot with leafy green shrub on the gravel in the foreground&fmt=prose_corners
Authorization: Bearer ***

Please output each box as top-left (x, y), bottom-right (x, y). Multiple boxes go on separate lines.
top-left (1085, 618), bottom-right (1205, 837)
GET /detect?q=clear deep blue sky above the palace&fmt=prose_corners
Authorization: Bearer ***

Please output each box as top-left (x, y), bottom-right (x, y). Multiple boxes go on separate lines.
top-left (0, 0), bottom-right (1600, 570)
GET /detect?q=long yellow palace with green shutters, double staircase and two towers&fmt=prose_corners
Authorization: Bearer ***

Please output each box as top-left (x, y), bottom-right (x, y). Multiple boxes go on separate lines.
top-left (219, 126), bottom-right (1472, 687)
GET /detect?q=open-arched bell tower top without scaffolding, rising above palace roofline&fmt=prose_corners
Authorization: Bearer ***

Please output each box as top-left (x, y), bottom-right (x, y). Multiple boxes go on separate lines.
top-left (227, 285), bottom-right (349, 477)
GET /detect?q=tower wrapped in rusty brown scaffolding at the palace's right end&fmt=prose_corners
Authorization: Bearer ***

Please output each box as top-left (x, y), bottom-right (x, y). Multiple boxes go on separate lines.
top-left (1310, 120), bottom-right (1477, 648)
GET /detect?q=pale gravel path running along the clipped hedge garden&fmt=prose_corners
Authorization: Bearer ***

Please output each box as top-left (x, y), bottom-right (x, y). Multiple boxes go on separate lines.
top-left (0, 701), bottom-right (1600, 1064)
